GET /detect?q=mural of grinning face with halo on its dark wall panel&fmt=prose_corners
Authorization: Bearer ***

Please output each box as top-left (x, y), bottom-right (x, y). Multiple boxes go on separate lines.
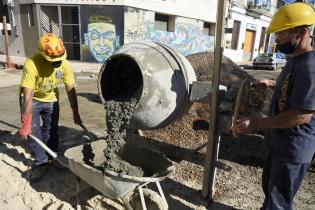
top-left (81, 6), bottom-right (124, 63)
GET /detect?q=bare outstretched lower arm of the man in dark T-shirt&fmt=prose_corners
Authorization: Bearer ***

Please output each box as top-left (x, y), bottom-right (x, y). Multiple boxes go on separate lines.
top-left (236, 109), bottom-right (314, 133)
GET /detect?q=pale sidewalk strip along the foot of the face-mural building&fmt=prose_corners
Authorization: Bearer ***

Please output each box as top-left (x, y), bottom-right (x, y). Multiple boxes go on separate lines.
top-left (0, 54), bottom-right (102, 73)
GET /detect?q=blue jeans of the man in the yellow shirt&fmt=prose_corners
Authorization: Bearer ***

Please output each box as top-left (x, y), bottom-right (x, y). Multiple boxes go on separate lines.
top-left (20, 100), bottom-right (60, 165)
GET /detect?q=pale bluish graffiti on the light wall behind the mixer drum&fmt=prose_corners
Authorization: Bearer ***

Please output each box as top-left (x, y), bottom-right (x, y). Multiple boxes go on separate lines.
top-left (125, 9), bottom-right (214, 56)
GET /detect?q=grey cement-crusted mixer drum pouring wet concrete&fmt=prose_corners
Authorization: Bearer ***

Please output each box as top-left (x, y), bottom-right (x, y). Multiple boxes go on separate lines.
top-left (98, 41), bottom-right (196, 129)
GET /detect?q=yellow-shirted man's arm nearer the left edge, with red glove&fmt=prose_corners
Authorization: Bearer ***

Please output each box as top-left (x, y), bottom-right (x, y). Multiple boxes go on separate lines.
top-left (19, 87), bottom-right (34, 140)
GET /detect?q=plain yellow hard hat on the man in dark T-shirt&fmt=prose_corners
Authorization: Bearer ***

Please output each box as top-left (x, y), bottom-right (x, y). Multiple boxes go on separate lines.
top-left (267, 2), bottom-right (315, 34)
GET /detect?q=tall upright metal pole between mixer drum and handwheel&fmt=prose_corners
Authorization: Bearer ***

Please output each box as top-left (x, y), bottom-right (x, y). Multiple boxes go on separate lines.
top-left (201, 0), bottom-right (226, 200)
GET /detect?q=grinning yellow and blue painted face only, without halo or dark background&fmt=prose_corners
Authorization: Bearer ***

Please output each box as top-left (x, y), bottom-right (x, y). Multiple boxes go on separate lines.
top-left (84, 23), bottom-right (119, 63)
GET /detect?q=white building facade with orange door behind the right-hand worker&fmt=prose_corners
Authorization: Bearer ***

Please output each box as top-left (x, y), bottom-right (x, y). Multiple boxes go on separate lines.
top-left (224, 0), bottom-right (314, 62)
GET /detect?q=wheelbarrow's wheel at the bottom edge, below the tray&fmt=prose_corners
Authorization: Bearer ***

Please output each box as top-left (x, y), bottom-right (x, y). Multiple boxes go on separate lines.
top-left (129, 188), bottom-right (168, 210)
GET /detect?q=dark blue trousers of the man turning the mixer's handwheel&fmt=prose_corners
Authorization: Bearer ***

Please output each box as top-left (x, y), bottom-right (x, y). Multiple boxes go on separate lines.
top-left (261, 154), bottom-right (310, 210)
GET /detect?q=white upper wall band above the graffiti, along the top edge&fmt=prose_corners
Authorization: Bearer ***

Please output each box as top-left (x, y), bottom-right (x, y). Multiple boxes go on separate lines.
top-left (17, 0), bottom-right (217, 22)
